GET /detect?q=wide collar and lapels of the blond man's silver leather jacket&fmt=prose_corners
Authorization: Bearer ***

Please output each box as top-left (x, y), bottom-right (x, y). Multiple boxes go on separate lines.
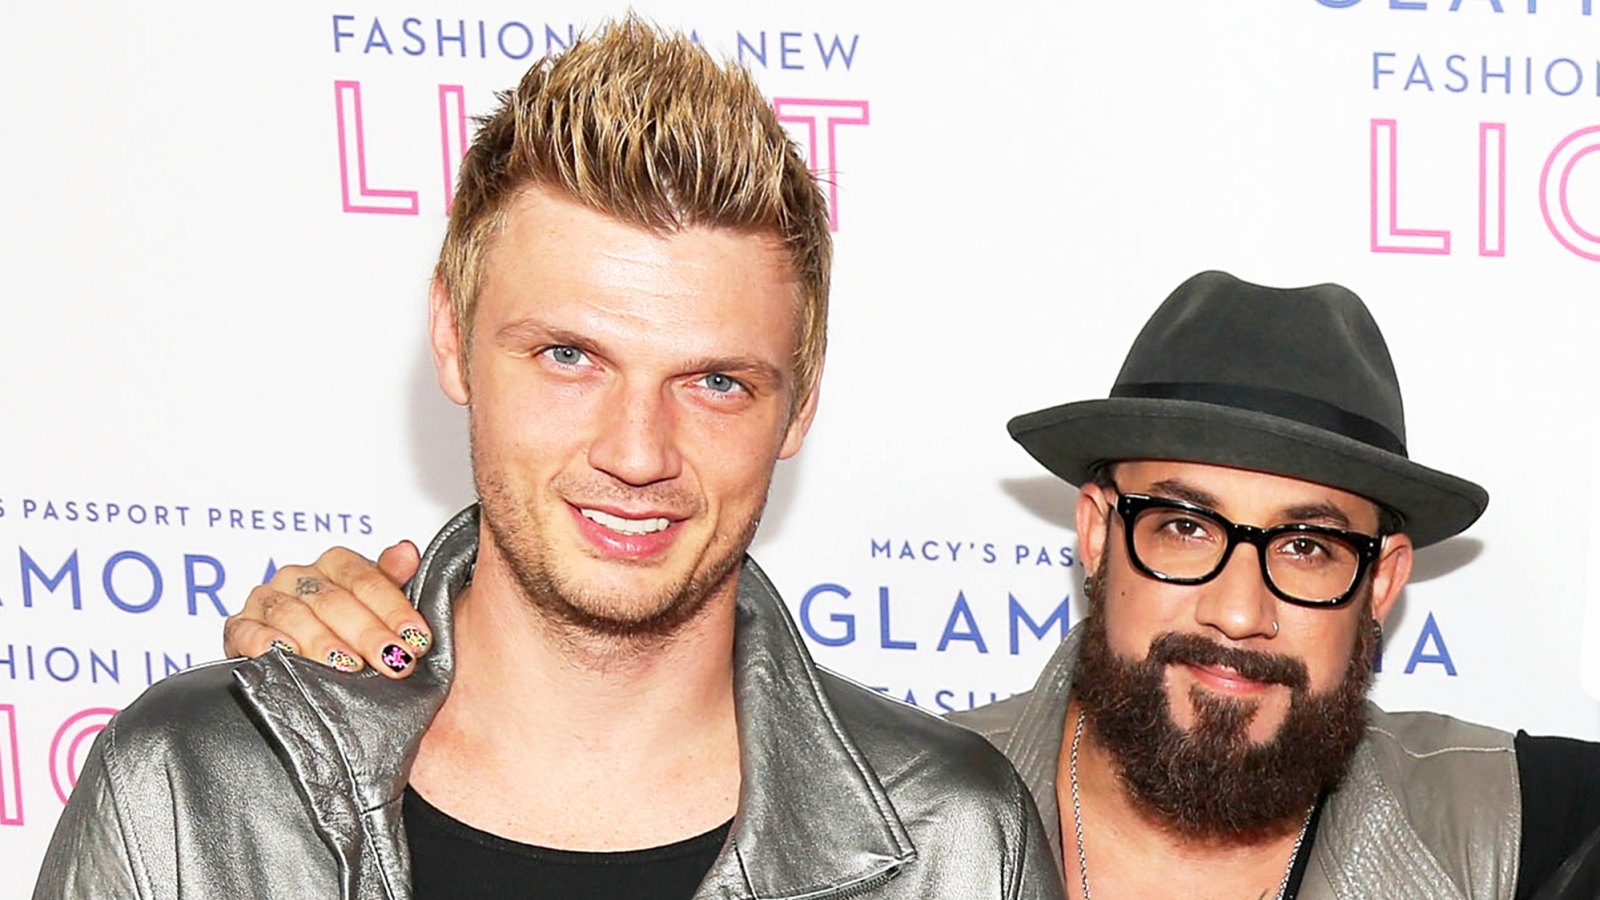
top-left (235, 506), bottom-right (917, 900)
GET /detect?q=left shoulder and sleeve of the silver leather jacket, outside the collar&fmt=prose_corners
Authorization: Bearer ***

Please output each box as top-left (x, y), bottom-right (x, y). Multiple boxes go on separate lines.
top-left (38, 660), bottom-right (339, 897)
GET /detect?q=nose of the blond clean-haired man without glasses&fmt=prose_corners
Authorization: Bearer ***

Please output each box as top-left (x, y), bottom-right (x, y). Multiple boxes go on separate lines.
top-left (589, 383), bottom-right (683, 485)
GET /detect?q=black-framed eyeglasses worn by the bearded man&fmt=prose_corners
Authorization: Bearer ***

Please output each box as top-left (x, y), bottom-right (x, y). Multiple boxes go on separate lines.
top-left (1117, 492), bottom-right (1384, 607)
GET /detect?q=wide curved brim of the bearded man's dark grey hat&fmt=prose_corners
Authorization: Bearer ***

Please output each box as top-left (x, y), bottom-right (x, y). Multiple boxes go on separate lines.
top-left (1006, 397), bottom-right (1490, 546)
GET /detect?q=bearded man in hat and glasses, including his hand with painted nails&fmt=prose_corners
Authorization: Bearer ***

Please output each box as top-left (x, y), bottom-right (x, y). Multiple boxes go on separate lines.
top-left (212, 272), bottom-right (1600, 900)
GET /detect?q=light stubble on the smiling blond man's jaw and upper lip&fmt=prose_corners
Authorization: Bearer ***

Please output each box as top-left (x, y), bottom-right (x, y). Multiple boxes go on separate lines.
top-left (472, 413), bottom-right (762, 650)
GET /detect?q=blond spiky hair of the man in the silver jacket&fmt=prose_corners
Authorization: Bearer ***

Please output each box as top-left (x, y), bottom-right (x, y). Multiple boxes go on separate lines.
top-left (437, 16), bottom-right (832, 408)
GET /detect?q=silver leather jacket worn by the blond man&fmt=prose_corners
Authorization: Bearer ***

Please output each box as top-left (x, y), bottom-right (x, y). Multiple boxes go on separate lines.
top-left (34, 508), bottom-right (1062, 900)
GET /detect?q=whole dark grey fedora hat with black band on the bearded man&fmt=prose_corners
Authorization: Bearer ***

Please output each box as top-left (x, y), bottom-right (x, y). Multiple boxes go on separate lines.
top-left (1008, 272), bottom-right (1490, 546)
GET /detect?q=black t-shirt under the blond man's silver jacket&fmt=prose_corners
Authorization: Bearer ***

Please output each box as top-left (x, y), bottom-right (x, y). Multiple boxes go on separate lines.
top-left (402, 788), bottom-right (733, 900)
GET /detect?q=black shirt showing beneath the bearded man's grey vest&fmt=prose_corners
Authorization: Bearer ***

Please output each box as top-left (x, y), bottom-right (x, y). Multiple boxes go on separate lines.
top-left (1285, 732), bottom-right (1600, 900)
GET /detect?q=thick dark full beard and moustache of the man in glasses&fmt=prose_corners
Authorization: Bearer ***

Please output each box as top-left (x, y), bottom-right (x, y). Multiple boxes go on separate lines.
top-left (1074, 563), bottom-right (1376, 844)
